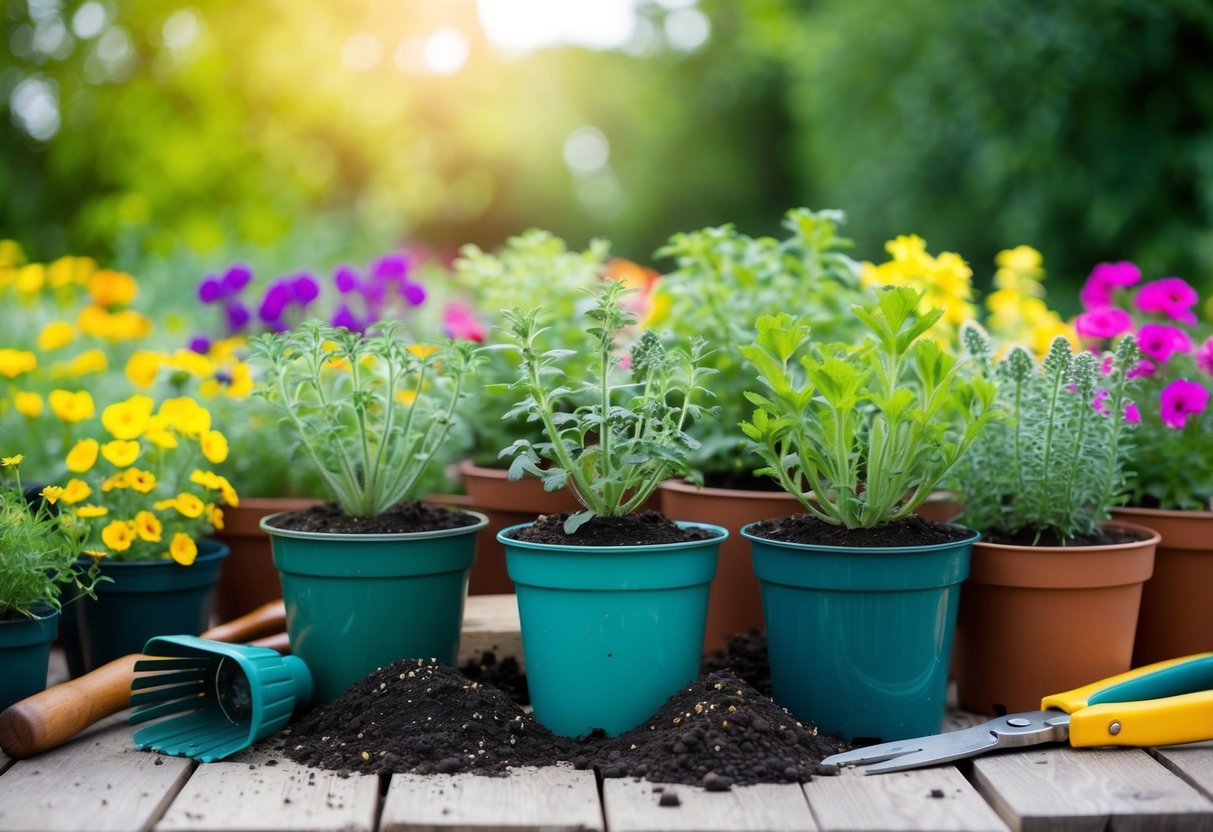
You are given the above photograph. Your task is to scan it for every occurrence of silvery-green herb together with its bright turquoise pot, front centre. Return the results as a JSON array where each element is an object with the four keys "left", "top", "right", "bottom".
[{"left": 497, "top": 280, "right": 728, "bottom": 736}]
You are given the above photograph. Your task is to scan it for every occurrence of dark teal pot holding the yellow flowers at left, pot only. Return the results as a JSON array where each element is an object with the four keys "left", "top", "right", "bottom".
[{"left": 63, "top": 540, "right": 228, "bottom": 677}]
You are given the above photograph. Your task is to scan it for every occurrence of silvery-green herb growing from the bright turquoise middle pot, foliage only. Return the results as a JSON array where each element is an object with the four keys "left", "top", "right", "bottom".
[{"left": 501, "top": 280, "right": 712, "bottom": 535}]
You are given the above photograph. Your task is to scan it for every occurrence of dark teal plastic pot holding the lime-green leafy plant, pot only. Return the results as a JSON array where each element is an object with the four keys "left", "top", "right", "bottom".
[{"left": 741, "top": 524, "right": 979, "bottom": 741}]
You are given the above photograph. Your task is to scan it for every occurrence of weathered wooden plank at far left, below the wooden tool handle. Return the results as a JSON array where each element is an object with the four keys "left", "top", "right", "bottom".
[{"left": 0, "top": 713, "right": 194, "bottom": 832}]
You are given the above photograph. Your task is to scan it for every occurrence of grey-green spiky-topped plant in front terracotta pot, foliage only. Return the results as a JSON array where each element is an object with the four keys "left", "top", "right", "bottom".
[{"left": 951, "top": 324, "right": 1140, "bottom": 543}]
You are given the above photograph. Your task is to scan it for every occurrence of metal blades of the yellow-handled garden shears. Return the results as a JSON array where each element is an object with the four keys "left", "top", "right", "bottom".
[{"left": 821, "top": 711, "right": 1070, "bottom": 774}]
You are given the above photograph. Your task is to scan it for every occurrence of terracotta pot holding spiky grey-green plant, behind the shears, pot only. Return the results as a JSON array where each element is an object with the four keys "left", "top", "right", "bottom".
[{"left": 956, "top": 523, "right": 1158, "bottom": 714}]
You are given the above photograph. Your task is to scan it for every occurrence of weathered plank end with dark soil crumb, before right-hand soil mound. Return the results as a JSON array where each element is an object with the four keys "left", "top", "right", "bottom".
[{"left": 603, "top": 779, "right": 818, "bottom": 832}]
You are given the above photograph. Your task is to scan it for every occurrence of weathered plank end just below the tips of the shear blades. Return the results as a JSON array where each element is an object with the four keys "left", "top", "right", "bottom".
[{"left": 804, "top": 765, "right": 1007, "bottom": 832}]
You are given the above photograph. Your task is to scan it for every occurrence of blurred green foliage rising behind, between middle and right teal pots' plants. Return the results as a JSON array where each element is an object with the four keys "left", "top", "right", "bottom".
[{"left": 656, "top": 209, "right": 866, "bottom": 485}]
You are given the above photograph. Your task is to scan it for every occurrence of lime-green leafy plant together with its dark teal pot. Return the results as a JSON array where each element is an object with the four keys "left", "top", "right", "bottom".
[{"left": 741, "top": 287, "right": 996, "bottom": 740}]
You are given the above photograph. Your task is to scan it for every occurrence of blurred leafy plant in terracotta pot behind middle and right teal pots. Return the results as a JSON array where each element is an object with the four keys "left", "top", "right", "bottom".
[{"left": 654, "top": 209, "right": 864, "bottom": 650}]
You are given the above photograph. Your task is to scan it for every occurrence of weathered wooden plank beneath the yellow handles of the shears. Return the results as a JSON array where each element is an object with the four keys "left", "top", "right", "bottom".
[{"left": 973, "top": 747, "right": 1213, "bottom": 832}]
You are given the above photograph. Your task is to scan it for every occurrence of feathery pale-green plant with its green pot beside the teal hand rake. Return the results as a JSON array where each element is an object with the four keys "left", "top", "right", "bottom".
[{"left": 252, "top": 321, "right": 488, "bottom": 701}]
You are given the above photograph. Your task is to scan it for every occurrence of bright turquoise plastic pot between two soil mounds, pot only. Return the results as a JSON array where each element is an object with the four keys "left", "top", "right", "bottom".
[{"left": 497, "top": 523, "right": 729, "bottom": 736}]
